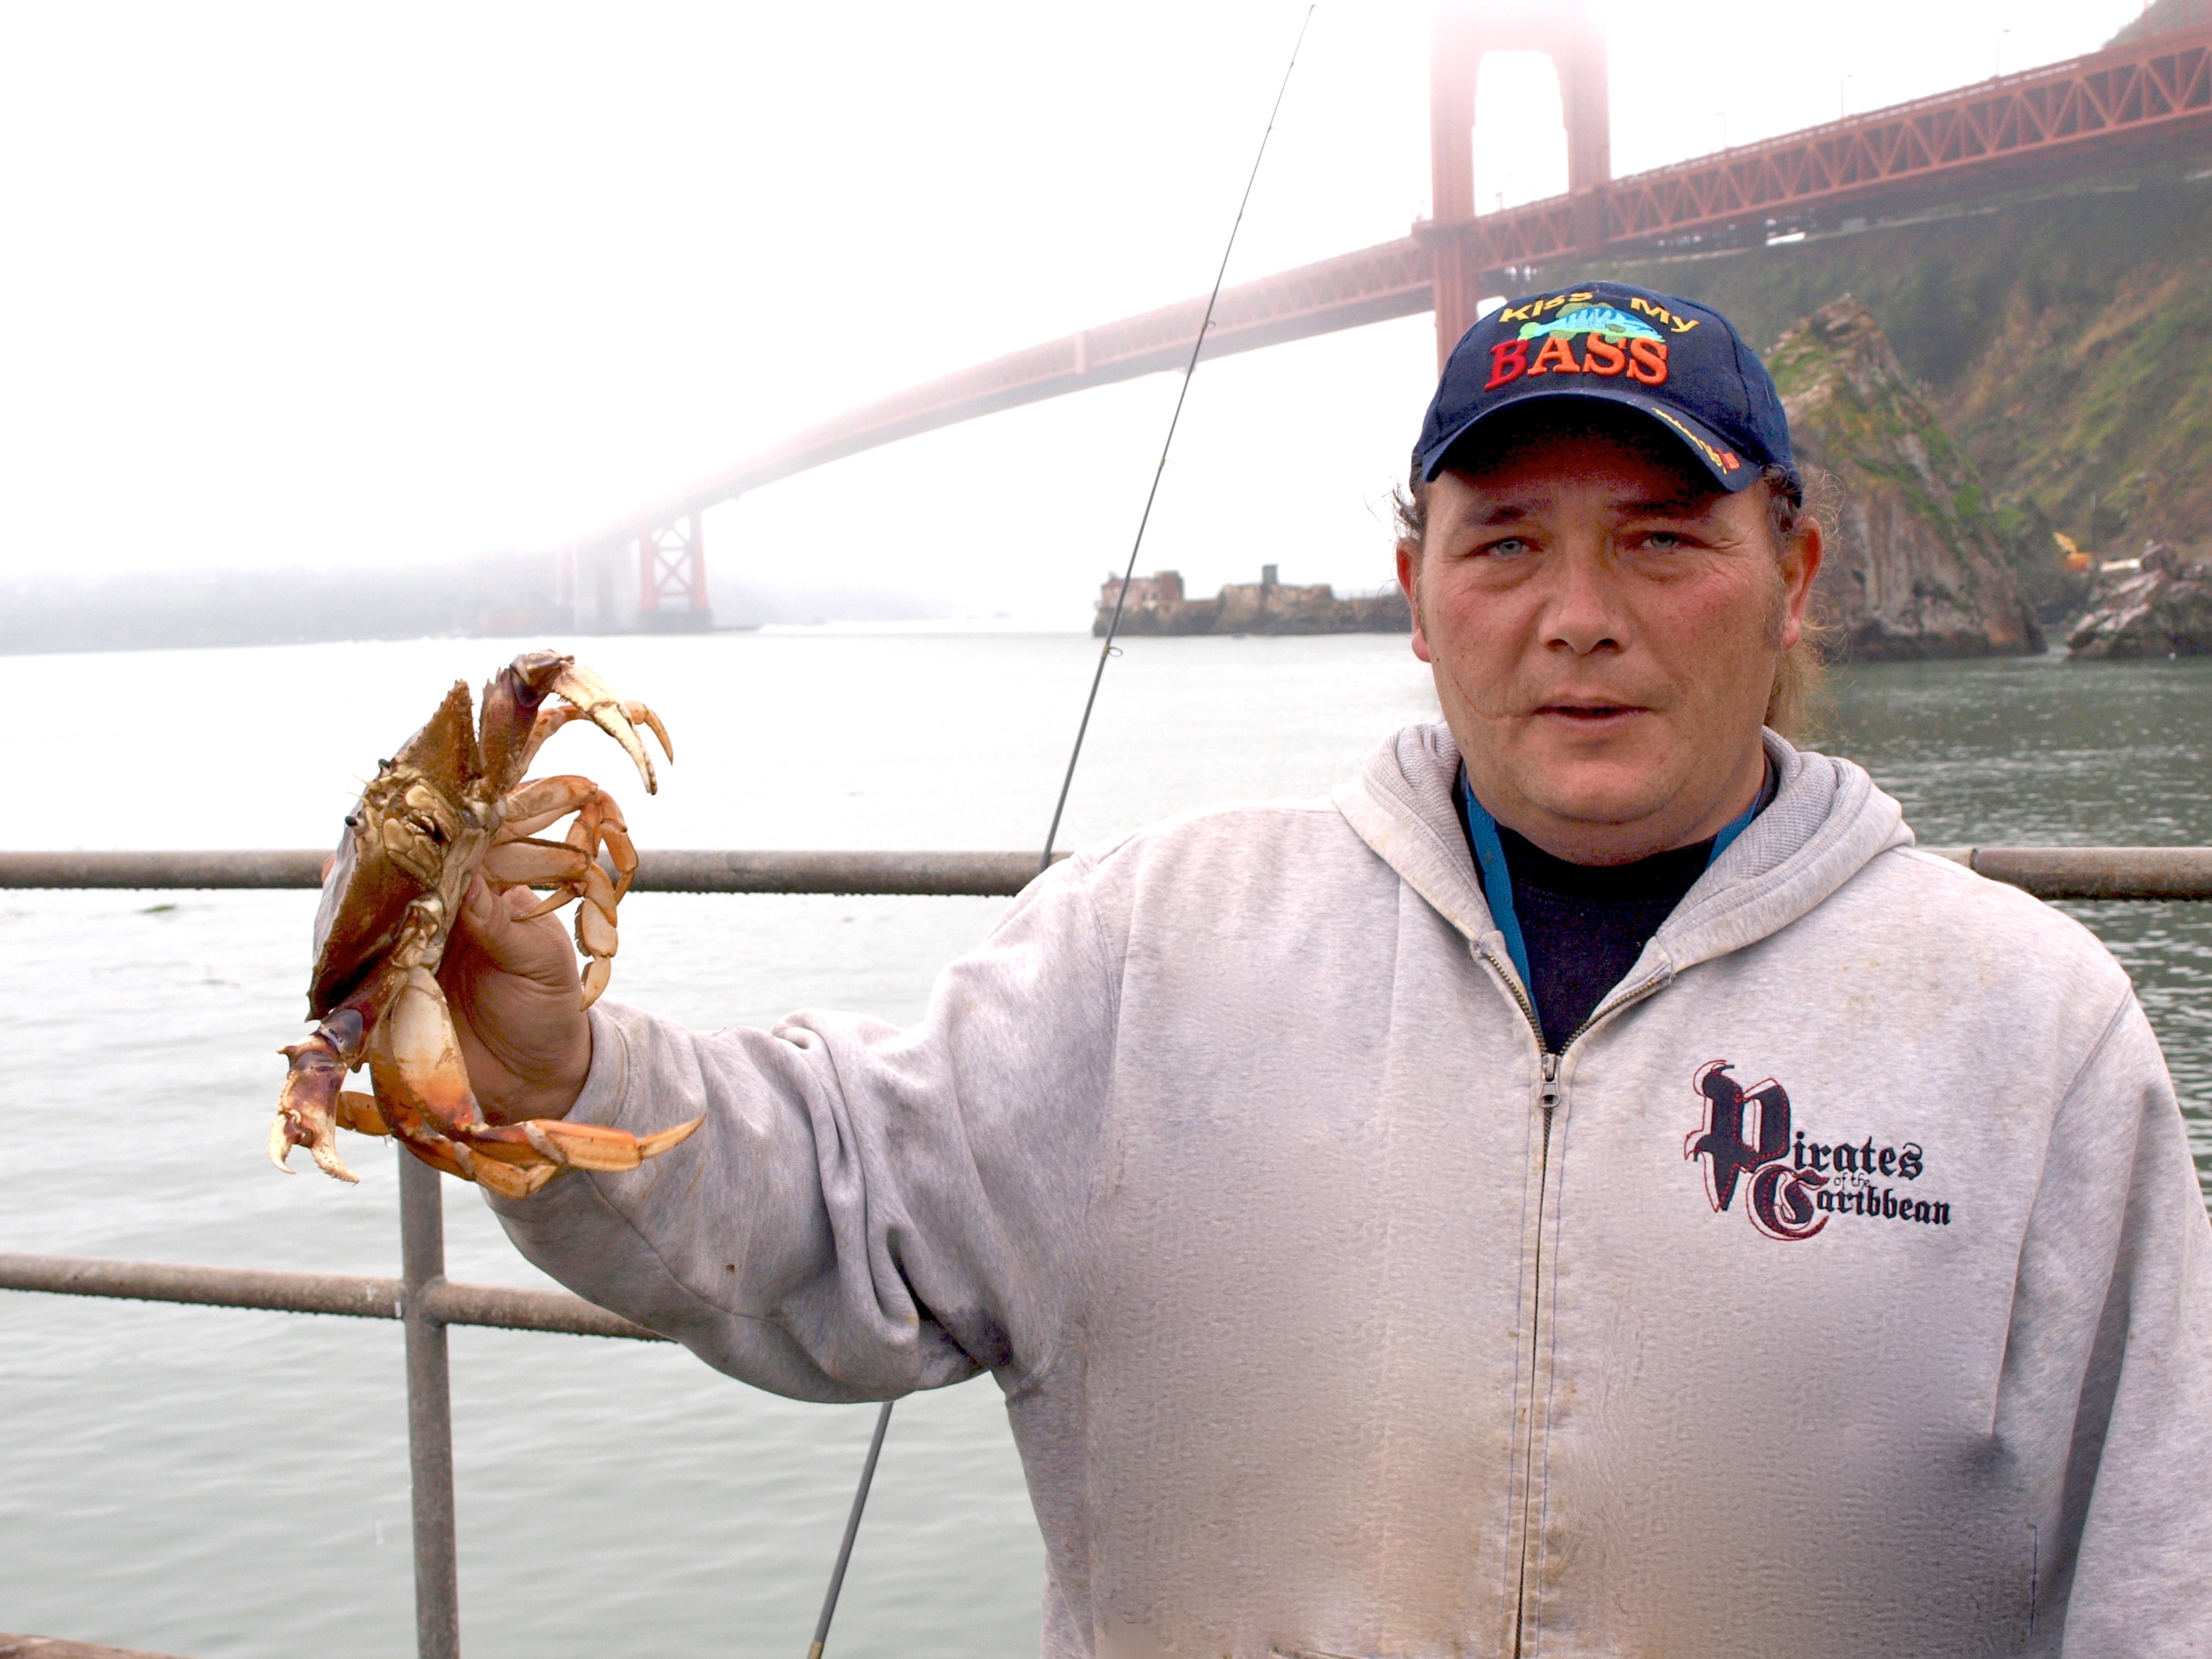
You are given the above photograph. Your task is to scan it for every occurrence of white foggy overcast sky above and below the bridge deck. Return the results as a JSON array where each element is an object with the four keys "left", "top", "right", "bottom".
[{"left": 0, "top": 0, "right": 2141, "bottom": 621}]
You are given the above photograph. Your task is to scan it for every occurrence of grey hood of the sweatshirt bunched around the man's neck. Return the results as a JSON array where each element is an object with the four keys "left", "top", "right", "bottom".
[{"left": 1334, "top": 723, "right": 1913, "bottom": 971}]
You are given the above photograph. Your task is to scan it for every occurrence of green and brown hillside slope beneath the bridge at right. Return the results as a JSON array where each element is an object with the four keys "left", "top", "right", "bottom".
[{"left": 1559, "top": 173, "right": 2212, "bottom": 602}]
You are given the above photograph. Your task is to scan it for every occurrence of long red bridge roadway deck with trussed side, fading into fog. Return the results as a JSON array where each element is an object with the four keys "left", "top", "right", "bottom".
[{"left": 577, "top": 16, "right": 2212, "bottom": 571}]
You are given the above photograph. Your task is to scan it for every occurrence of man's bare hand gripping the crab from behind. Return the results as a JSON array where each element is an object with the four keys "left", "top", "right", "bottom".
[{"left": 438, "top": 878, "right": 591, "bottom": 1124}]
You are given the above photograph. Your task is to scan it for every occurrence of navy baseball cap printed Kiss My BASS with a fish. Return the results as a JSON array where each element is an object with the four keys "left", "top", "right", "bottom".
[{"left": 1413, "top": 283, "right": 1796, "bottom": 491}]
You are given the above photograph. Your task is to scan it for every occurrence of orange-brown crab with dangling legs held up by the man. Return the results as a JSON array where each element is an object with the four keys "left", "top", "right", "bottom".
[{"left": 270, "top": 650, "right": 699, "bottom": 1197}]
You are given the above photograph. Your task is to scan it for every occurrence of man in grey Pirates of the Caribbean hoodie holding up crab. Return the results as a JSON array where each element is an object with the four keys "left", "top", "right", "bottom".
[{"left": 447, "top": 283, "right": 2212, "bottom": 1659}]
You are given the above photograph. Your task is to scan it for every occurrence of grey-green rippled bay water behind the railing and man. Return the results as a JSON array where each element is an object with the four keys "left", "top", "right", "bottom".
[{"left": 0, "top": 631, "right": 2212, "bottom": 1659}]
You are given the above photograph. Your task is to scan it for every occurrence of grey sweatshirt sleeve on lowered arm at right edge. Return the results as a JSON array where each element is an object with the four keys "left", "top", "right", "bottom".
[{"left": 2007, "top": 995, "right": 2212, "bottom": 1659}]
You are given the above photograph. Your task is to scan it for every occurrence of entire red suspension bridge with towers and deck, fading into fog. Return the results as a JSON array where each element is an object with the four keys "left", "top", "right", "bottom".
[{"left": 566, "top": 5, "right": 2212, "bottom": 631}]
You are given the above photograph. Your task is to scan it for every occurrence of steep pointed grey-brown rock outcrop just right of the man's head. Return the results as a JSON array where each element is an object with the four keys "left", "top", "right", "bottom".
[{"left": 1770, "top": 299, "right": 2044, "bottom": 661}]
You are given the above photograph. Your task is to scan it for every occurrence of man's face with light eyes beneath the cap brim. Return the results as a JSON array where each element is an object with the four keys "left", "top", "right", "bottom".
[{"left": 1398, "top": 411, "right": 1821, "bottom": 865}]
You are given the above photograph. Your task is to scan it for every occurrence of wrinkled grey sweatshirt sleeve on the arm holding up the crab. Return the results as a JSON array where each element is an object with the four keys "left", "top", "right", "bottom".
[{"left": 486, "top": 858, "right": 1117, "bottom": 1400}]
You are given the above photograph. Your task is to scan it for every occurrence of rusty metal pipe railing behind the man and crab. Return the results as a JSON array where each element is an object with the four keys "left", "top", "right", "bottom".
[{"left": 0, "top": 847, "right": 2212, "bottom": 1659}]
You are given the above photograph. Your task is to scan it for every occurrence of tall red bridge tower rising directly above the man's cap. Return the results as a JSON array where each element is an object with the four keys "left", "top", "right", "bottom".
[{"left": 1429, "top": 0, "right": 1613, "bottom": 365}]
